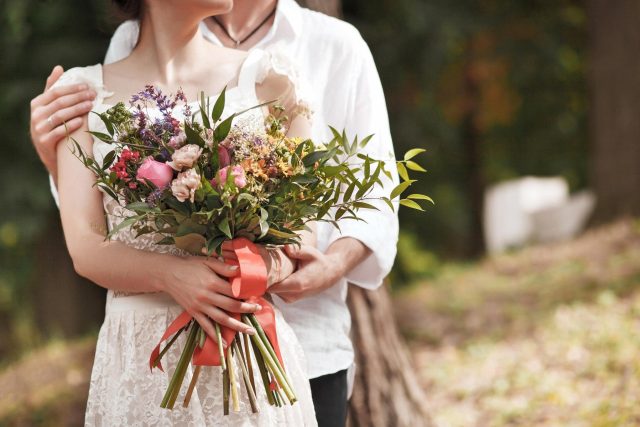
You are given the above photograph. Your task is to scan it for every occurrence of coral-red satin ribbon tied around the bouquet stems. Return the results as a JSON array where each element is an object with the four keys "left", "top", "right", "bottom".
[{"left": 149, "top": 237, "right": 284, "bottom": 372}]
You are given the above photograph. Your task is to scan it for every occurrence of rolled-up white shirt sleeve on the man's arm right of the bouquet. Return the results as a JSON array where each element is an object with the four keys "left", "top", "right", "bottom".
[{"left": 329, "top": 36, "right": 398, "bottom": 289}]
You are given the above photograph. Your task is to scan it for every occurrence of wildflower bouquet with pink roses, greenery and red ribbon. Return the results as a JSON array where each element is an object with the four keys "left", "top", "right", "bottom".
[{"left": 74, "top": 86, "right": 430, "bottom": 414}]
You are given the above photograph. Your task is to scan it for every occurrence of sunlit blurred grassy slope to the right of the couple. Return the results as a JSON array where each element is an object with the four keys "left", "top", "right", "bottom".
[{"left": 396, "top": 221, "right": 640, "bottom": 427}]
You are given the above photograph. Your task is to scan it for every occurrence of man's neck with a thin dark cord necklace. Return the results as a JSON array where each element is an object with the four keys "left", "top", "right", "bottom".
[{"left": 206, "top": 0, "right": 278, "bottom": 50}]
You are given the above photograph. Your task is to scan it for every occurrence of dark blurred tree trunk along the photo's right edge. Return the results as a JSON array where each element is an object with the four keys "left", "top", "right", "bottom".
[{"left": 587, "top": 0, "right": 640, "bottom": 222}]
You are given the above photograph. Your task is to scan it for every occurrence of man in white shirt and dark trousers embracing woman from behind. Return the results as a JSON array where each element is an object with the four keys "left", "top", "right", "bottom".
[{"left": 31, "top": 0, "right": 398, "bottom": 427}]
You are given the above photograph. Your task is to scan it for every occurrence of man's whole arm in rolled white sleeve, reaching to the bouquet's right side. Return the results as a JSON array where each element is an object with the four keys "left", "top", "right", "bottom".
[{"left": 270, "top": 31, "right": 398, "bottom": 302}]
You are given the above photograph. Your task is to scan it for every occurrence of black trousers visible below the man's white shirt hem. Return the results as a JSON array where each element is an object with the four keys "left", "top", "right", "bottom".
[{"left": 310, "top": 369, "right": 348, "bottom": 427}]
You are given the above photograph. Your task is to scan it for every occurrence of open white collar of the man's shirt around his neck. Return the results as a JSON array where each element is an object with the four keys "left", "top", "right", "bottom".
[{"left": 200, "top": 0, "right": 302, "bottom": 48}]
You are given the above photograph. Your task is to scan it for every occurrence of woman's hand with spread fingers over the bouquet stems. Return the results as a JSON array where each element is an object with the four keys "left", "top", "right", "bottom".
[{"left": 161, "top": 256, "right": 261, "bottom": 340}]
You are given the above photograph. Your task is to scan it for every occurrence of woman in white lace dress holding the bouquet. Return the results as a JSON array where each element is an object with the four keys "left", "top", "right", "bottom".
[{"left": 57, "top": 0, "right": 316, "bottom": 426}]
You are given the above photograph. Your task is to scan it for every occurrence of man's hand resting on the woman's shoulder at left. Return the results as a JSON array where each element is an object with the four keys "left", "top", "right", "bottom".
[{"left": 30, "top": 65, "right": 96, "bottom": 180}]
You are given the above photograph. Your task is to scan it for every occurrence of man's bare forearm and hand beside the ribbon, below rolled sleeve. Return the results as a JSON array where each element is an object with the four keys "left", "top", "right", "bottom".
[{"left": 269, "top": 237, "right": 371, "bottom": 302}]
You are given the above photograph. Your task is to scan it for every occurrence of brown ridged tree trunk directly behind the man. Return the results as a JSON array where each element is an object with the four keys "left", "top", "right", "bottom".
[{"left": 298, "top": 0, "right": 432, "bottom": 427}]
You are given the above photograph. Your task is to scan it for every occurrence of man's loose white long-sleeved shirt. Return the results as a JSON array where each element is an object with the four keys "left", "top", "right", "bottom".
[{"left": 65, "top": 0, "right": 398, "bottom": 378}]
